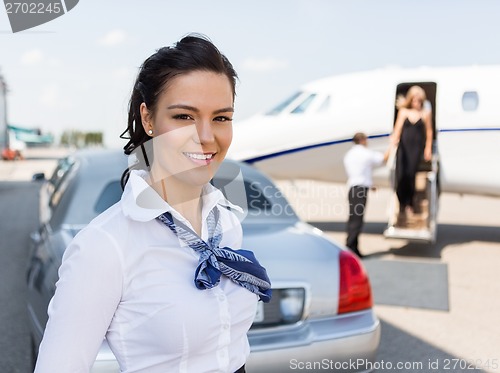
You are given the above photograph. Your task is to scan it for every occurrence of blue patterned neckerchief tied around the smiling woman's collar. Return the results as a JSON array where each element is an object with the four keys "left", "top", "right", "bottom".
[{"left": 157, "top": 207, "right": 271, "bottom": 302}]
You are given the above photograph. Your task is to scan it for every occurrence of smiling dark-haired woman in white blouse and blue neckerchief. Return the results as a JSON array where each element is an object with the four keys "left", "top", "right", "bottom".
[{"left": 35, "top": 35, "right": 271, "bottom": 373}]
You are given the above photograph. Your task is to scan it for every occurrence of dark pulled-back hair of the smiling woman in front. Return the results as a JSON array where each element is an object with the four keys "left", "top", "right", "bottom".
[{"left": 120, "top": 34, "right": 238, "bottom": 185}]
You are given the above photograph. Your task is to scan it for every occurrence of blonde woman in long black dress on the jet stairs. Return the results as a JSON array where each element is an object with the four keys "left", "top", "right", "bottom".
[{"left": 393, "top": 86, "right": 432, "bottom": 214}]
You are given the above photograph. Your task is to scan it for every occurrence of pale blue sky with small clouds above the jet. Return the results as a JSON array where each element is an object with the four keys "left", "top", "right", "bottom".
[{"left": 0, "top": 0, "right": 500, "bottom": 147}]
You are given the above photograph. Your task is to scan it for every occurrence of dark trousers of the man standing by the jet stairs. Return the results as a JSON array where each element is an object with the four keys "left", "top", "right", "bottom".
[{"left": 346, "top": 185, "right": 369, "bottom": 256}]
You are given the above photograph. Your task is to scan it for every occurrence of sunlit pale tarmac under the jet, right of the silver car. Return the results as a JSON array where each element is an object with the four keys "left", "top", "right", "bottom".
[{"left": 278, "top": 180, "right": 500, "bottom": 372}]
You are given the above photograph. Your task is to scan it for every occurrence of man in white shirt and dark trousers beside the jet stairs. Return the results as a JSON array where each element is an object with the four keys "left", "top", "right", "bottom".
[{"left": 344, "top": 132, "right": 389, "bottom": 257}]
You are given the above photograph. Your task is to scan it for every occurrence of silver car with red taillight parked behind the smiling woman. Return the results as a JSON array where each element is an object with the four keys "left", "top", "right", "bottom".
[{"left": 27, "top": 150, "right": 380, "bottom": 373}]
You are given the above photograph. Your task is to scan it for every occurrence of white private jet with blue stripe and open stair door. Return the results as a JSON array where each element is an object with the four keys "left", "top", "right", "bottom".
[{"left": 229, "top": 65, "right": 500, "bottom": 242}]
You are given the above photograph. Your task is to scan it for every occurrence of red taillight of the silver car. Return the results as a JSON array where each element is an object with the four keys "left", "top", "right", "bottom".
[{"left": 338, "top": 250, "right": 373, "bottom": 314}]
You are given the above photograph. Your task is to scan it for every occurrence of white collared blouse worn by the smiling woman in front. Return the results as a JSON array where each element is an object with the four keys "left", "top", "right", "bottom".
[{"left": 35, "top": 171, "right": 258, "bottom": 373}]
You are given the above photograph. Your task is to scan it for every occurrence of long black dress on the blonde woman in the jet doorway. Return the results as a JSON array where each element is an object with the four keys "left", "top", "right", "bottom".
[{"left": 396, "top": 118, "right": 425, "bottom": 211}]
